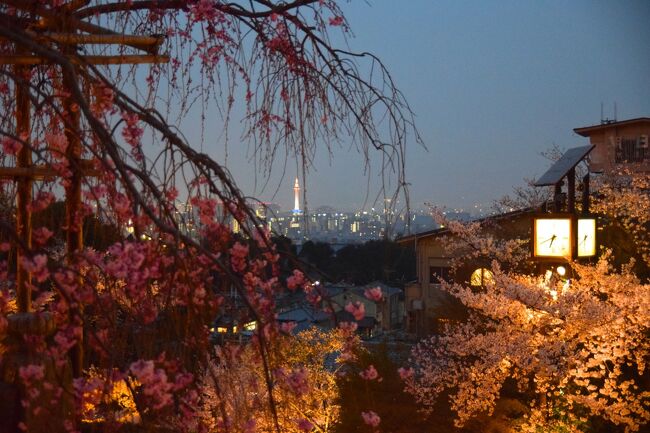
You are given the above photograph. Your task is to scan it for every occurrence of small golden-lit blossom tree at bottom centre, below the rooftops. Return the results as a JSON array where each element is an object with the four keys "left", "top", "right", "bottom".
[{"left": 201, "top": 329, "right": 346, "bottom": 433}]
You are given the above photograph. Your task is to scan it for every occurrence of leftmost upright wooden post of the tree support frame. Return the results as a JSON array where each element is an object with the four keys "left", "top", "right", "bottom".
[{"left": 15, "top": 66, "right": 32, "bottom": 313}]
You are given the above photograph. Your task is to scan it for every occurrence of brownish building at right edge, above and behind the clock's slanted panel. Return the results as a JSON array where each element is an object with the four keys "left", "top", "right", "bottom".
[{"left": 573, "top": 117, "right": 650, "bottom": 173}]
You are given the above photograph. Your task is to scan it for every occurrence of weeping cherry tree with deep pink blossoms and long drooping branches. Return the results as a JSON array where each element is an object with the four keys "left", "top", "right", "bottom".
[{"left": 0, "top": 0, "right": 419, "bottom": 431}]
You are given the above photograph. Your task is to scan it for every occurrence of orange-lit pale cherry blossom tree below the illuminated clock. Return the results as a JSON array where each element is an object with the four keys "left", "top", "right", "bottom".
[{"left": 401, "top": 203, "right": 650, "bottom": 432}]
